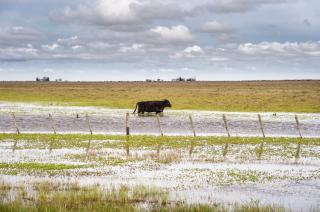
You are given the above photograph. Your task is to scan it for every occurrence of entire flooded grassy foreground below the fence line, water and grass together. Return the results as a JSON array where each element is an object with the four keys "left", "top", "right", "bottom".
[{"left": 0, "top": 134, "right": 320, "bottom": 211}]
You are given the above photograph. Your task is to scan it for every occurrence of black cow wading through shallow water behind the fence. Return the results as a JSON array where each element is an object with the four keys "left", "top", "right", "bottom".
[{"left": 133, "top": 99, "right": 171, "bottom": 114}]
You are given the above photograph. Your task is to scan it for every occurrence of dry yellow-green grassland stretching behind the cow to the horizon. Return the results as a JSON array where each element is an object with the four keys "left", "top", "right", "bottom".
[{"left": 0, "top": 80, "right": 320, "bottom": 112}]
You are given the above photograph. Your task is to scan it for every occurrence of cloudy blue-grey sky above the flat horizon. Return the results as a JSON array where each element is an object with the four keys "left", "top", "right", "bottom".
[{"left": 0, "top": 0, "right": 320, "bottom": 81}]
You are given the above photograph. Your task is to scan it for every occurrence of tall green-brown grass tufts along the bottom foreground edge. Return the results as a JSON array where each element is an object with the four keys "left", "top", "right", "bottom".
[{"left": 0, "top": 182, "right": 285, "bottom": 212}]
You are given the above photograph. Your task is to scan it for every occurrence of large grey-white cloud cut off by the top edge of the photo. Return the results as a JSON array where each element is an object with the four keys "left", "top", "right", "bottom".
[{"left": 51, "top": 0, "right": 191, "bottom": 27}]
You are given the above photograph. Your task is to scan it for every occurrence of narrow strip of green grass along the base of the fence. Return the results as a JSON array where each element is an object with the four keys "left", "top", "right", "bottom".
[{"left": 0, "top": 133, "right": 320, "bottom": 149}]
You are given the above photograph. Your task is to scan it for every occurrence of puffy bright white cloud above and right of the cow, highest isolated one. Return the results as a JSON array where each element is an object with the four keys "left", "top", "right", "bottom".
[{"left": 150, "top": 25, "right": 194, "bottom": 42}]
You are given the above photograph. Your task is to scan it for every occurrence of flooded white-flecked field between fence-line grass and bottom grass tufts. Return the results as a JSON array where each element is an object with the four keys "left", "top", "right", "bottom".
[{"left": 0, "top": 136, "right": 320, "bottom": 211}]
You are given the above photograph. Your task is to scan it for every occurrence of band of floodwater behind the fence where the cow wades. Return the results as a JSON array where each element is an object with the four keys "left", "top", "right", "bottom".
[{"left": 0, "top": 103, "right": 320, "bottom": 137}]
